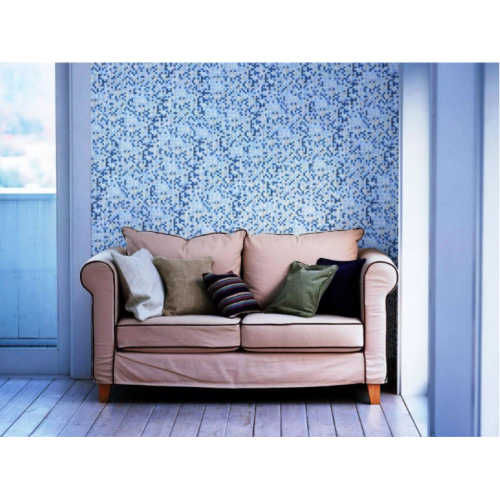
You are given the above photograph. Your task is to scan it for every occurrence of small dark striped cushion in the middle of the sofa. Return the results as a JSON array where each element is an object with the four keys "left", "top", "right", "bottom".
[{"left": 203, "top": 272, "right": 262, "bottom": 318}]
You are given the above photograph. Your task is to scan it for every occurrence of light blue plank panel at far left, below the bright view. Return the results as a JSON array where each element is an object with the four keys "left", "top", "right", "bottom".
[{"left": 0, "top": 193, "right": 57, "bottom": 346}]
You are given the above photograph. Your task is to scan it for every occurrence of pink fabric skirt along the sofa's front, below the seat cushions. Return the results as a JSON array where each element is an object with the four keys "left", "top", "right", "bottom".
[{"left": 112, "top": 351, "right": 365, "bottom": 389}]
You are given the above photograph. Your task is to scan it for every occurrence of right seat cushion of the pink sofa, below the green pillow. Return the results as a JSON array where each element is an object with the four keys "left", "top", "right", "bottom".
[{"left": 241, "top": 314, "right": 363, "bottom": 352}]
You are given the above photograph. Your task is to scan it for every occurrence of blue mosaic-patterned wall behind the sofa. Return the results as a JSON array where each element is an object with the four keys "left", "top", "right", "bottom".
[{"left": 91, "top": 63, "right": 399, "bottom": 356}]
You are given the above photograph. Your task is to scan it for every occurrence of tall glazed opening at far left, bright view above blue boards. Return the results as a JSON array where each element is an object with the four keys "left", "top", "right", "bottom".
[{"left": 0, "top": 64, "right": 58, "bottom": 348}]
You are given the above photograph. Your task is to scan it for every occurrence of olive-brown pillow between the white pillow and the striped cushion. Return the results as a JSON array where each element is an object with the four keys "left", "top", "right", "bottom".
[{"left": 153, "top": 257, "right": 220, "bottom": 316}]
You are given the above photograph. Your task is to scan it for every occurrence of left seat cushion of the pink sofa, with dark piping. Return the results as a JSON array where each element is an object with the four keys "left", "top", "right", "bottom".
[{"left": 116, "top": 315, "right": 241, "bottom": 354}]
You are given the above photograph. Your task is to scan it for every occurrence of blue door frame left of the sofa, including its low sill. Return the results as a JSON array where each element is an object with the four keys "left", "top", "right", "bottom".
[{"left": 0, "top": 63, "right": 92, "bottom": 378}]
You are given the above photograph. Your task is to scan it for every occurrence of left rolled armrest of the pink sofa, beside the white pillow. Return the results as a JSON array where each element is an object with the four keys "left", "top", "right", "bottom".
[{"left": 80, "top": 248, "right": 126, "bottom": 384}]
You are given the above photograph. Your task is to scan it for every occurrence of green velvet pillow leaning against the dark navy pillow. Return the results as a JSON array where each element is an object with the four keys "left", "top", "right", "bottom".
[{"left": 264, "top": 262, "right": 338, "bottom": 318}]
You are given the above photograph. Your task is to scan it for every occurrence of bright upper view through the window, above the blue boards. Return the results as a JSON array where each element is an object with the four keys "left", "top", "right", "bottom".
[{"left": 0, "top": 63, "right": 56, "bottom": 191}]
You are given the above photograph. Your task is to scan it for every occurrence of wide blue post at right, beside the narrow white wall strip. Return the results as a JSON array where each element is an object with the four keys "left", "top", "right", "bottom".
[{"left": 429, "top": 63, "right": 498, "bottom": 436}]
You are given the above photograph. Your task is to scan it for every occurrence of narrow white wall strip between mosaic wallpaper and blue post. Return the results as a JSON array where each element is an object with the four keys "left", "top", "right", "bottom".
[{"left": 398, "top": 64, "right": 430, "bottom": 396}]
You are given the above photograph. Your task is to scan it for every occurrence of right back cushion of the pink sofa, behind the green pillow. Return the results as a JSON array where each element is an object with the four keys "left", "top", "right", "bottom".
[{"left": 243, "top": 229, "right": 364, "bottom": 309}]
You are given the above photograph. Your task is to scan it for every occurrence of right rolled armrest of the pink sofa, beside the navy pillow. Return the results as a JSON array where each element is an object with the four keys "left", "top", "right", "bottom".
[{"left": 358, "top": 248, "right": 398, "bottom": 384}]
